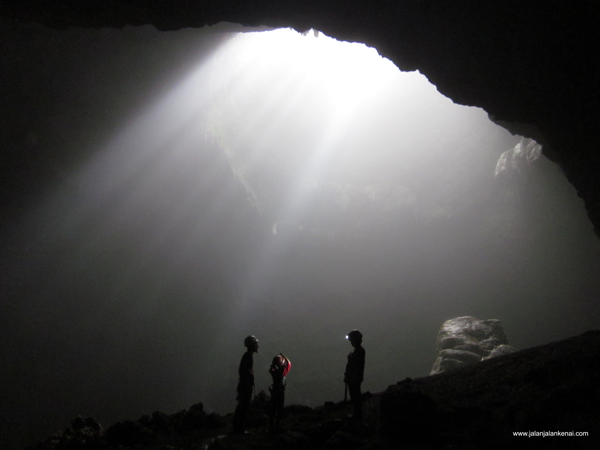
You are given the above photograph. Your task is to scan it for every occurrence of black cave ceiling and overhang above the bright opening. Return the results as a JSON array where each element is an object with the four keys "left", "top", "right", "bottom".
[{"left": 0, "top": 0, "right": 600, "bottom": 234}]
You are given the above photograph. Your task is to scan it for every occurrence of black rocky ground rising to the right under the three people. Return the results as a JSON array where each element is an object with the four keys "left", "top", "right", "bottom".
[{"left": 27, "top": 331, "right": 600, "bottom": 450}]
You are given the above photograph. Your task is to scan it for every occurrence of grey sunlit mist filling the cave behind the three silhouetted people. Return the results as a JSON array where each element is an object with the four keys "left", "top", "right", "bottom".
[{"left": 0, "top": 23, "right": 600, "bottom": 448}]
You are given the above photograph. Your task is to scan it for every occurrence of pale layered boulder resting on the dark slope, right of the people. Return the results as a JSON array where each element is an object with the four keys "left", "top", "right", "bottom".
[{"left": 430, "top": 316, "right": 515, "bottom": 375}]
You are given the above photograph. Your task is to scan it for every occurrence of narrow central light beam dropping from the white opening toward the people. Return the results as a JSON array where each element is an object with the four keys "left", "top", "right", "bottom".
[{"left": 214, "top": 29, "right": 435, "bottom": 317}]
